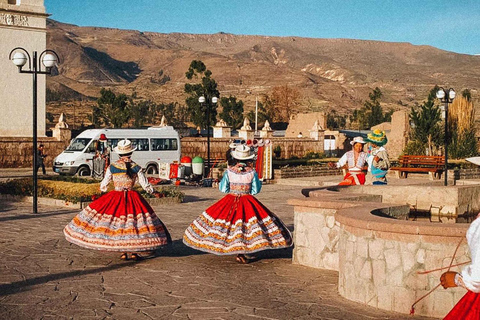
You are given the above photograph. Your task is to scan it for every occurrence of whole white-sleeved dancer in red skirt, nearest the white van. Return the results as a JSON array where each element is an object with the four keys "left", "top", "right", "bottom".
[{"left": 63, "top": 140, "right": 171, "bottom": 260}]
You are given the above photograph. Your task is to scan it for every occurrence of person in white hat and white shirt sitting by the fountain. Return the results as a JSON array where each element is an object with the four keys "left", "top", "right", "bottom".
[{"left": 328, "top": 137, "right": 367, "bottom": 186}]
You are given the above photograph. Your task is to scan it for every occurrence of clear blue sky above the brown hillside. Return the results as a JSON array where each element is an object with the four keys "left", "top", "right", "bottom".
[{"left": 45, "top": 0, "right": 480, "bottom": 54}]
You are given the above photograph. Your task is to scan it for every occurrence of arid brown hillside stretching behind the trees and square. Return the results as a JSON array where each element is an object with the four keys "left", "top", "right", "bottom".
[{"left": 47, "top": 20, "right": 480, "bottom": 125}]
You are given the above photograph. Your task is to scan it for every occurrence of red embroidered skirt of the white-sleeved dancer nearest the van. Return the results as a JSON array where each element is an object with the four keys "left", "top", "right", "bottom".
[{"left": 63, "top": 191, "right": 171, "bottom": 252}]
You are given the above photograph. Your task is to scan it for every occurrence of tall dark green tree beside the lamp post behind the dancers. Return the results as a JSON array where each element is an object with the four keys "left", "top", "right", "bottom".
[{"left": 184, "top": 60, "right": 220, "bottom": 128}]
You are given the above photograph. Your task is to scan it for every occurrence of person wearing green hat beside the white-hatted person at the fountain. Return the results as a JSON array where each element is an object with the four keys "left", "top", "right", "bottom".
[{"left": 366, "top": 129, "right": 390, "bottom": 185}]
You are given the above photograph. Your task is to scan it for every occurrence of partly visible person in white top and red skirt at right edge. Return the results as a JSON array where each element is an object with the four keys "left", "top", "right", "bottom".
[{"left": 440, "top": 214, "right": 480, "bottom": 320}]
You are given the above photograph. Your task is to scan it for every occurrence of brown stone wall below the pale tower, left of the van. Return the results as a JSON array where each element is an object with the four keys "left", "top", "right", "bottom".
[{"left": 0, "top": 137, "right": 70, "bottom": 168}]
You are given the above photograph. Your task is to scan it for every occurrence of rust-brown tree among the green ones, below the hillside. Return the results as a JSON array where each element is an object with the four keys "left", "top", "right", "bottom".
[{"left": 271, "top": 84, "right": 300, "bottom": 122}]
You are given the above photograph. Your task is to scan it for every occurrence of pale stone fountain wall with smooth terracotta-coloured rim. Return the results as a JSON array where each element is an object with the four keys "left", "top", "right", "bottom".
[{"left": 288, "top": 186, "right": 474, "bottom": 317}]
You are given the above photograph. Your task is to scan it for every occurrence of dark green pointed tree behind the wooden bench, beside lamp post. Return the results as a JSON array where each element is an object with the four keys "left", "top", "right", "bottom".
[{"left": 405, "top": 86, "right": 443, "bottom": 154}]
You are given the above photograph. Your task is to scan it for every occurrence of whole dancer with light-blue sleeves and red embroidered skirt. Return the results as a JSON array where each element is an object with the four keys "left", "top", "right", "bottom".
[{"left": 183, "top": 145, "right": 292, "bottom": 263}]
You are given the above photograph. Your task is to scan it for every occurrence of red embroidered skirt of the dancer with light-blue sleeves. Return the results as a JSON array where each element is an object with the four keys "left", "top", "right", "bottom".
[{"left": 183, "top": 194, "right": 292, "bottom": 255}]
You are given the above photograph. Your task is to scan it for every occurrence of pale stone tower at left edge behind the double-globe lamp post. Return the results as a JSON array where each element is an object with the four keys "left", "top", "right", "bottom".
[{"left": 0, "top": 0, "right": 48, "bottom": 137}]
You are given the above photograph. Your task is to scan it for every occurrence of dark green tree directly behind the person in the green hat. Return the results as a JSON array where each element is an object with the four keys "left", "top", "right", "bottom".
[{"left": 350, "top": 87, "right": 393, "bottom": 129}]
